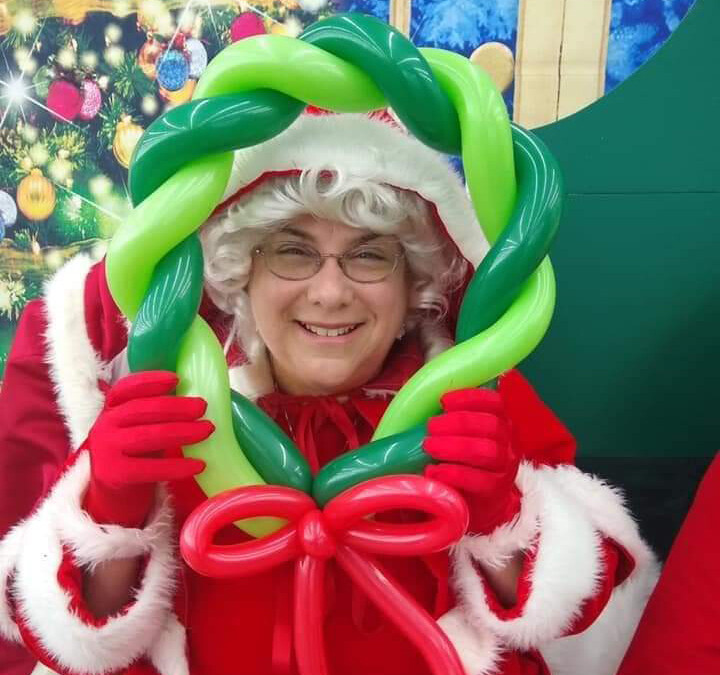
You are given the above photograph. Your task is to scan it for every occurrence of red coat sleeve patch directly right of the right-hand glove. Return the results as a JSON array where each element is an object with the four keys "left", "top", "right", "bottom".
[{"left": 498, "top": 370, "right": 576, "bottom": 466}]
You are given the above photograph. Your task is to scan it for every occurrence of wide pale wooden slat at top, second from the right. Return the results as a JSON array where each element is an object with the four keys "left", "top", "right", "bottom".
[{"left": 514, "top": 0, "right": 566, "bottom": 128}]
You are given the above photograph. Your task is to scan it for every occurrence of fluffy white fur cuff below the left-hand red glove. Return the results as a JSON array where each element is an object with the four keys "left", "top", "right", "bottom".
[{"left": 6, "top": 452, "right": 187, "bottom": 675}]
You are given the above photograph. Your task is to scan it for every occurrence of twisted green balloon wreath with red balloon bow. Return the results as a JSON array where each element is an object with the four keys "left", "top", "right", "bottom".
[{"left": 107, "top": 14, "right": 563, "bottom": 675}]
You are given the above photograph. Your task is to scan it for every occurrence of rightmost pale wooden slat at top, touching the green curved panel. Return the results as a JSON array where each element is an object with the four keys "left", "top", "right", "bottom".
[{"left": 557, "top": 0, "right": 612, "bottom": 119}]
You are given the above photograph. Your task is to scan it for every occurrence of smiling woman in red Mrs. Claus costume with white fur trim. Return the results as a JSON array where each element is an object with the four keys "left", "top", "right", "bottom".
[{"left": 0, "top": 115, "right": 654, "bottom": 675}]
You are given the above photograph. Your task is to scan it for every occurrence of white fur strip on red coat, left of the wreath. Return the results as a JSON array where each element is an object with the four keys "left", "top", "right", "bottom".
[{"left": 45, "top": 255, "right": 110, "bottom": 448}]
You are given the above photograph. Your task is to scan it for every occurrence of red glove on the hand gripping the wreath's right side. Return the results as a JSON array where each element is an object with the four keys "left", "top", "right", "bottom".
[{"left": 423, "top": 389, "right": 520, "bottom": 534}]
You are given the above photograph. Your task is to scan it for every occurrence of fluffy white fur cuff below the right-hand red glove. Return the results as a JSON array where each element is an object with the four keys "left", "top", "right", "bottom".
[{"left": 454, "top": 463, "right": 612, "bottom": 650}]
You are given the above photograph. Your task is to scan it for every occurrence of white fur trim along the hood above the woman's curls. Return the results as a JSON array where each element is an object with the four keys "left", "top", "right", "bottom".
[{"left": 222, "top": 114, "right": 488, "bottom": 267}]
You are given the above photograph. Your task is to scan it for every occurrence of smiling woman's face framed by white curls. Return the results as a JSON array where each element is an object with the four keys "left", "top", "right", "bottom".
[{"left": 247, "top": 216, "right": 409, "bottom": 395}]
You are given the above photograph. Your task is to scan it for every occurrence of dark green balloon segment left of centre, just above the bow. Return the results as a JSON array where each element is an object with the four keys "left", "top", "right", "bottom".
[{"left": 230, "top": 391, "right": 312, "bottom": 493}]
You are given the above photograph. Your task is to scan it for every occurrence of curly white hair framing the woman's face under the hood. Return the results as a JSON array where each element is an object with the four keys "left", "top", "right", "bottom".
[{"left": 200, "top": 169, "right": 468, "bottom": 363}]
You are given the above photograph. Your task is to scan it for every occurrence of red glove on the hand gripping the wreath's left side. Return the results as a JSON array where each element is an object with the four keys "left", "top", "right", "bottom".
[{"left": 83, "top": 371, "right": 215, "bottom": 527}]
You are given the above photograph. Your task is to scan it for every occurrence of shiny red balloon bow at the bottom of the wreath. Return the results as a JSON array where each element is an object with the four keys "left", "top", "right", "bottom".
[{"left": 180, "top": 475, "right": 468, "bottom": 675}]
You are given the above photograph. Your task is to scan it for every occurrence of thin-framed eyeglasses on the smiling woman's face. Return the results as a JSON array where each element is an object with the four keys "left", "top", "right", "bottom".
[{"left": 255, "top": 241, "right": 403, "bottom": 284}]
